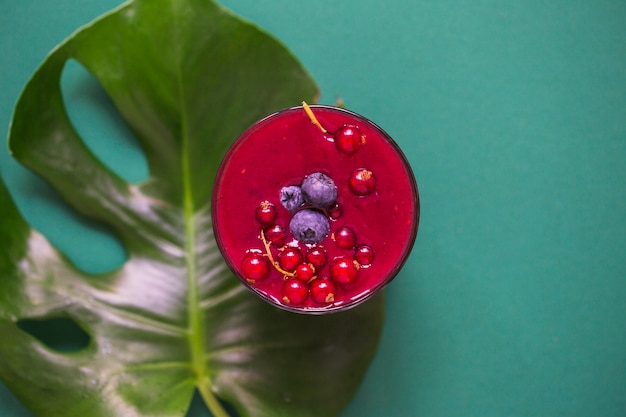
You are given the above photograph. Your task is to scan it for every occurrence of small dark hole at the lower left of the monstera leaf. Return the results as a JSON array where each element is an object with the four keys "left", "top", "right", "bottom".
[{"left": 17, "top": 317, "right": 91, "bottom": 353}]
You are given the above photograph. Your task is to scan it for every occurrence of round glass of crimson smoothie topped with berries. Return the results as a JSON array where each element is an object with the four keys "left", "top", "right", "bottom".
[{"left": 212, "top": 105, "right": 419, "bottom": 314}]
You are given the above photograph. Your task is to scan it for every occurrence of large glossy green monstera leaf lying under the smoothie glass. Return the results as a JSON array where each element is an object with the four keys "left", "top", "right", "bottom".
[{"left": 0, "top": 0, "right": 382, "bottom": 417}]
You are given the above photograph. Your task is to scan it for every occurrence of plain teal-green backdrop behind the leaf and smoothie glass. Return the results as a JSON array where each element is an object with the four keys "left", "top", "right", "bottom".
[{"left": 0, "top": 0, "right": 626, "bottom": 417}]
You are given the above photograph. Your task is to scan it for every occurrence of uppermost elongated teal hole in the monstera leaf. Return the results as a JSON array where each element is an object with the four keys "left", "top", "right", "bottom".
[{"left": 61, "top": 59, "right": 149, "bottom": 183}]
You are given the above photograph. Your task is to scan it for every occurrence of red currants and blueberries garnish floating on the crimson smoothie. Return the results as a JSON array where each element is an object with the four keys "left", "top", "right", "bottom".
[{"left": 240, "top": 107, "right": 376, "bottom": 306}]
